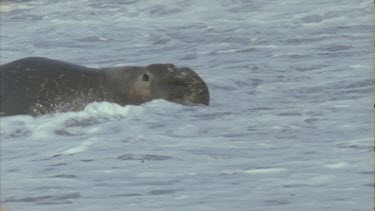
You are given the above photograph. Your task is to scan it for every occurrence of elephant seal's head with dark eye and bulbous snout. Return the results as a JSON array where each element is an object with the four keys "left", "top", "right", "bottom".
[{"left": 107, "top": 64, "right": 210, "bottom": 105}]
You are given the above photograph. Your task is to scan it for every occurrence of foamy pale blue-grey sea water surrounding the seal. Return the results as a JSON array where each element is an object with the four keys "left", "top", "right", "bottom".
[{"left": 0, "top": 0, "right": 374, "bottom": 211}]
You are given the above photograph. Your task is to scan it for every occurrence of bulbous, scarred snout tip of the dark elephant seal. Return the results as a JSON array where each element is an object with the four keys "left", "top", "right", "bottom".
[{"left": 175, "top": 67, "right": 210, "bottom": 105}]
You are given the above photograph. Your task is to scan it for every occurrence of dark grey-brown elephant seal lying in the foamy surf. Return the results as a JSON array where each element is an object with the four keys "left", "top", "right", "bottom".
[{"left": 0, "top": 57, "right": 209, "bottom": 116}]
